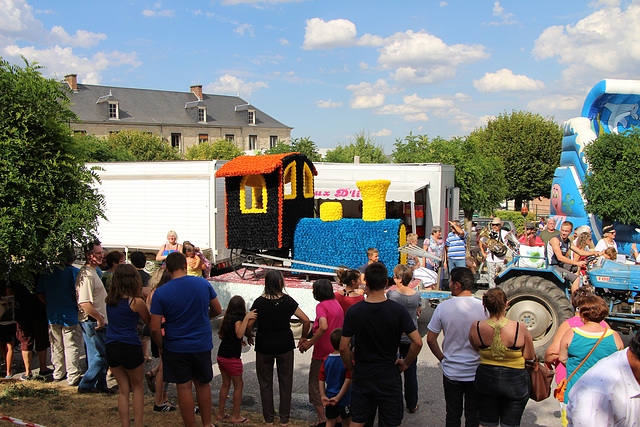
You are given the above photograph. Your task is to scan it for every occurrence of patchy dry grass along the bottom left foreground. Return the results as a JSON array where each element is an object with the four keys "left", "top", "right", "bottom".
[{"left": 0, "top": 380, "right": 308, "bottom": 427}]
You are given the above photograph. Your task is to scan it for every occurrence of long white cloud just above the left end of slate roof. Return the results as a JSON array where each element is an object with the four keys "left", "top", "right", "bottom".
[{"left": 4, "top": 45, "right": 141, "bottom": 84}]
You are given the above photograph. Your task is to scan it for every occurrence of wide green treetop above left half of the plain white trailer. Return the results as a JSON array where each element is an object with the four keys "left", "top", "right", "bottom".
[{"left": 106, "top": 130, "right": 182, "bottom": 162}]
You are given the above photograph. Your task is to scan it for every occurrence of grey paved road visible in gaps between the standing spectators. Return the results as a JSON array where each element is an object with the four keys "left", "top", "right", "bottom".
[{"left": 202, "top": 309, "right": 560, "bottom": 427}]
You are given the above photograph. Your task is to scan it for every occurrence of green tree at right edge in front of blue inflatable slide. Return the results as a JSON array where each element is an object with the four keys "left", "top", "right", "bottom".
[{"left": 582, "top": 129, "right": 640, "bottom": 224}]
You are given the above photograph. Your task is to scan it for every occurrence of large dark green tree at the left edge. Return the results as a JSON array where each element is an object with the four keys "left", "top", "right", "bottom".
[{"left": 0, "top": 58, "right": 103, "bottom": 285}]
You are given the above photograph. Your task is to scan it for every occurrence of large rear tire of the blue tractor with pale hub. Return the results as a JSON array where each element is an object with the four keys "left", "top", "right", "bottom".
[{"left": 500, "top": 276, "right": 574, "bottom": 360}]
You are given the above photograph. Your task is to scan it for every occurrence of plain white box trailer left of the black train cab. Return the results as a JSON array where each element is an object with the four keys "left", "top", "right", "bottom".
[{"left": 86, "top": 160, "right": 230, "bottom": 265}]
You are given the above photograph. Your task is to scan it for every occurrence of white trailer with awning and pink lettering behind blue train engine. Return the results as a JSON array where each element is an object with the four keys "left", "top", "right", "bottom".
[{"left": 314, "top": 162, "right": 459, "bottom": 237}]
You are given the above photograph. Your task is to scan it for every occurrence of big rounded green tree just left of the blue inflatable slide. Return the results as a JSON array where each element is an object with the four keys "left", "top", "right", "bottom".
[{"left": 470, "top": 111, "right": 562, "bottom": 210}]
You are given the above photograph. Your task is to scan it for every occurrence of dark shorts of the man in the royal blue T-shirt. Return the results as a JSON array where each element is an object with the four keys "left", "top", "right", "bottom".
[{"left": 162, "top": 349, "right": 213, "bottom": 384}]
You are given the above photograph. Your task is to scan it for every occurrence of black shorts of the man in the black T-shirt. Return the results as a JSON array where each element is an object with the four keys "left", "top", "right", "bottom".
[{"left": 351, "top": 368, "right": 404, "bottom": 426}]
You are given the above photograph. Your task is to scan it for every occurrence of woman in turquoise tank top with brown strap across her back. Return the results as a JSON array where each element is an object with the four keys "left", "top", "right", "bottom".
[{"left": 558, "top": 295, "right": 624, "bottom": 426}]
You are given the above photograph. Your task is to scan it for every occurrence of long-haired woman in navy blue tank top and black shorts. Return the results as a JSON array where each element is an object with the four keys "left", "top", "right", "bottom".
[{"left": 105, "top": 264, "right": 151, "bottom": 427}]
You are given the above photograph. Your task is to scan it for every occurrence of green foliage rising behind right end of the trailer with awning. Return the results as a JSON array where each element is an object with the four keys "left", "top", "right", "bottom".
[{"left": 392, "top": 134, "right": 506, "bottom": 220}]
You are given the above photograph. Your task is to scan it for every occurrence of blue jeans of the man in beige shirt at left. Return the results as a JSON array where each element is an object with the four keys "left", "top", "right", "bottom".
[{"left": 78, "top": 320, "right": 109, "bottom": 390}]
